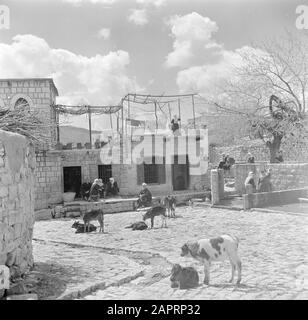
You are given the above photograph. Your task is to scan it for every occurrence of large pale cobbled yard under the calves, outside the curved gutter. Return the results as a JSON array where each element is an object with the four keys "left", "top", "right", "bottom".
[{"left": 34, "top": 206, "right": 308, "bottom": 299}]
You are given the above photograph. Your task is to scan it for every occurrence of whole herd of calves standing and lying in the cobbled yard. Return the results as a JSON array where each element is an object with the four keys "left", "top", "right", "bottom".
[{"left": 67, "top": 196, "right": 242, "bottom": 289}]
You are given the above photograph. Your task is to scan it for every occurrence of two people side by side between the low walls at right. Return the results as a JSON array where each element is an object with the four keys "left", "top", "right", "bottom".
[{"left": 245, "top": 169, "right": 273, "bottom": 194}]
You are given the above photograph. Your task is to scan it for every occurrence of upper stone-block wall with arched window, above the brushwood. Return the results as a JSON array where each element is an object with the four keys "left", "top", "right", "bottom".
[{"left": 0, "top": 79, "right": 58, "bottom": 150}]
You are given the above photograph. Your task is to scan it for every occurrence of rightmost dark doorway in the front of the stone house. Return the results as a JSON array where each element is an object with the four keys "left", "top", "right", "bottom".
[{"left": 172, "top": 155, "right": 189, "bottom": 190}]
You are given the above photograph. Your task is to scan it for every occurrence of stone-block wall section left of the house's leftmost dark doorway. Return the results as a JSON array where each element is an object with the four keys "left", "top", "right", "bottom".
[{"left": 35, "top": 151, "right": 63, "bottom": 209}]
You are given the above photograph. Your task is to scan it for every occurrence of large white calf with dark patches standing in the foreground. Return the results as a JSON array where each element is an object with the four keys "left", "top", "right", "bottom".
[{"left": 181, "top": 235, "right": 242, "bottom": 285}]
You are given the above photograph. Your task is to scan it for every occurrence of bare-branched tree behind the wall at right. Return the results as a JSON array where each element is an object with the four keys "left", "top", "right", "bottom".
[{"left": 208, "top": 32, "right": 308, "bottom": 162}]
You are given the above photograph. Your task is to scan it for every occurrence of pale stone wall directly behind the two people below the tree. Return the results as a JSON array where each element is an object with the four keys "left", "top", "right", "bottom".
[{"left": 234, "top": 163, "right": 308, "bottom": 194}]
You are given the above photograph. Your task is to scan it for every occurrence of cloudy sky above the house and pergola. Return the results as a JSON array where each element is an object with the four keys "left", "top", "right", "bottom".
[{"left": 0, "top": 0, "right": 308, "bottom": 129}]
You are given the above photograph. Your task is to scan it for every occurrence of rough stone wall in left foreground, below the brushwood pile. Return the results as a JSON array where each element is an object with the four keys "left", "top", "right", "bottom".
[{"left": 0, "top": 130, "right": 35, "bottom": 278}]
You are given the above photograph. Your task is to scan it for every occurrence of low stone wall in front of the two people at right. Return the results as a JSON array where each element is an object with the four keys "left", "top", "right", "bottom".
[{"left": 243, "top": 188, "right": 308, "bottom": 210}]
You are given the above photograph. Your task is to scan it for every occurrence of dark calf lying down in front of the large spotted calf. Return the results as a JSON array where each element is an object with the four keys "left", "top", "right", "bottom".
[{"left": 170, "top": 264, "right": 199, "bottom": 289}]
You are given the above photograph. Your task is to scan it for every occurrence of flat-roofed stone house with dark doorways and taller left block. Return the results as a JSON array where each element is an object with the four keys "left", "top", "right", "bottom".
[{"left": 0, "top": 78, "right": 210, "bottom": 209}]
